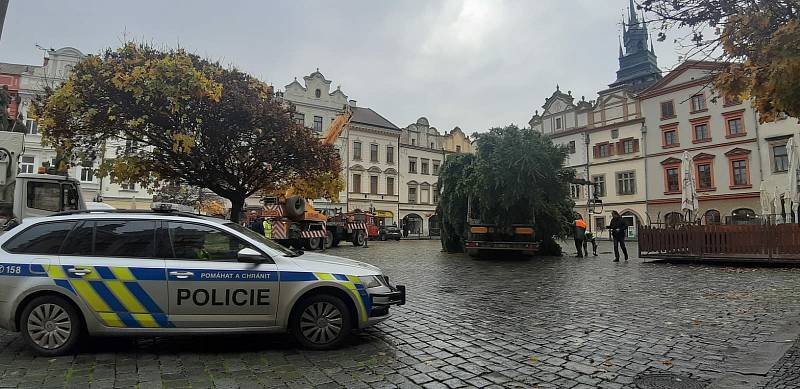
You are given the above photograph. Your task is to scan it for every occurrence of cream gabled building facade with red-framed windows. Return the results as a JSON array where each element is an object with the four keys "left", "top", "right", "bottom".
[{"left": 639, "top": 61, "right": 764, "bottom": 223}]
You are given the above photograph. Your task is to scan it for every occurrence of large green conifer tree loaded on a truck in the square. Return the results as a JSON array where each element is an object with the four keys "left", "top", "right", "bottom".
[{"left": 437, "top": 125, "right": 575, "bottom": 255}]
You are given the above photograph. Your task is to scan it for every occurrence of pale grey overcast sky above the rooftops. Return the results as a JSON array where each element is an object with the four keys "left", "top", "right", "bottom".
[{"left": 0, "top": 0, "right": 678, "bottom": 133}]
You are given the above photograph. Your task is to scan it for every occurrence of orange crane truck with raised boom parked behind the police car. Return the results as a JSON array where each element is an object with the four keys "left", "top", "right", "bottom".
[{"left": 248, "top": 107, "right": 372, "bottom": 250}]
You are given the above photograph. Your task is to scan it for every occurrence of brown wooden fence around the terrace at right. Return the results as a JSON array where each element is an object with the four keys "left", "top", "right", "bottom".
[{"left": 639, "top": 224, "right": 800, "bottom": 260}]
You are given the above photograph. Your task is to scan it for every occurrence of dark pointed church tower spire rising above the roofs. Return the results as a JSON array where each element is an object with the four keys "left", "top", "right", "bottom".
[{"left": 609, "top": 0, "right": 661, "bottom": 91}]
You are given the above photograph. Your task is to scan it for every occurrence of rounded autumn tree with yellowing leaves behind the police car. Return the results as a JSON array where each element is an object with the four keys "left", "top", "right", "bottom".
[{"left": 34, "top": 43, "right": 340, "bottom": 221}]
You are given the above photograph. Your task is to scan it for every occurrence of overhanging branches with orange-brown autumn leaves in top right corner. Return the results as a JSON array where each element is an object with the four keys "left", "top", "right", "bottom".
[{"left": 641, "top": 0, "right": 800, "bottom": 122}]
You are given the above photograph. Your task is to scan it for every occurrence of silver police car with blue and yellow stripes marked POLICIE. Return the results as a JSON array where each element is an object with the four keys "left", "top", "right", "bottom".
[{"left": 0, "top": 206, "right": 405, "bottom": 355}]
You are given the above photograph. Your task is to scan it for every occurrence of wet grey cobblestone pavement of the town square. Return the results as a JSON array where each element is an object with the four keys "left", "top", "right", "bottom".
[{"left": 0, "top": 241, "right": 800, "bottom": 389}]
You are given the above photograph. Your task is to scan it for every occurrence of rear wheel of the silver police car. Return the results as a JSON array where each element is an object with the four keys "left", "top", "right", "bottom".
[{"left": 20, "top": 296, "right": 83, "bottom": 356}]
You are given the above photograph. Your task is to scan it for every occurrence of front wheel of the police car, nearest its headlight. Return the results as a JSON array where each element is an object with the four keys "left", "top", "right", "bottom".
[{"left": 291, "top": 294, "right": 352, "bottom": 350}]
